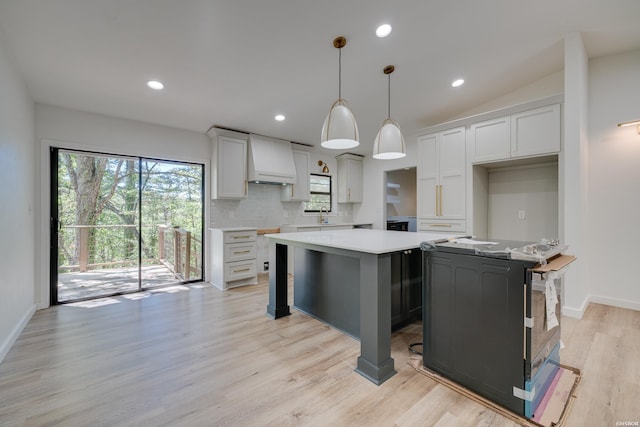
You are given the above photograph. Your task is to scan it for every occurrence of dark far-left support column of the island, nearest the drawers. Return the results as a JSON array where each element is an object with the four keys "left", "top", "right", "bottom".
[{"left": 267, "top": 243, "right": 291, "bottom": 319}]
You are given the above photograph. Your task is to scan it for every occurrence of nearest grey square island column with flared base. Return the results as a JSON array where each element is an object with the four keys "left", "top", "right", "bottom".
[{"left": 356, "top": 253, "right": 396, "bottom": 385}]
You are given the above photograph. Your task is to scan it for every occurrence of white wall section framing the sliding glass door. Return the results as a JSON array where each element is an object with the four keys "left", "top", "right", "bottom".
[{"left": 31, "top": 104, "right": 211, "bottom": 307}]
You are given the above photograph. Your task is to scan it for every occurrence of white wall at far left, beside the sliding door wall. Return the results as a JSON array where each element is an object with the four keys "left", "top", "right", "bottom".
[{"left": 0, "top": 34, "right": 35, "bottom": 362}]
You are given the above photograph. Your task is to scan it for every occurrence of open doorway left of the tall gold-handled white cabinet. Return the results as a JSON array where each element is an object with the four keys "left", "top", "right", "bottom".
[{"left": 384, "top": 167, "right": 417, "bottom": 231}]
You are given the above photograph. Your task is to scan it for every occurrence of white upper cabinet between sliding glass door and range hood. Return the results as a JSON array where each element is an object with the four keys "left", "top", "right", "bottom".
[{"left": 208, "top": 131, "right": 247, "bottom": 199}]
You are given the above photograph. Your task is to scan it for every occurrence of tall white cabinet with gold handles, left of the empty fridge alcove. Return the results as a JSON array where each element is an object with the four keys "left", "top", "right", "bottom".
[{"left": 417, "top": 127, "right": 466, "bottom": 231}]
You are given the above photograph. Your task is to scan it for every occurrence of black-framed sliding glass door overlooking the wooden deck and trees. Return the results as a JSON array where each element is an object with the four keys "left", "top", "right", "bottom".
[{"left": 50, "top": 148, "right": 204, "bottom": 304}]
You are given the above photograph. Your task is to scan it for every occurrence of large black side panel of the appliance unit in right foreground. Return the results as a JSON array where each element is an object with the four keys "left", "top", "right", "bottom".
[{"left": 423, "top": 247, "right": 535, "bottom": 414}]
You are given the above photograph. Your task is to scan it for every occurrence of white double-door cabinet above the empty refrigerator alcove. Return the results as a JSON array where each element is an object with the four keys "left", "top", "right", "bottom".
[{"left": 469, "top": 104, "right": 561, "bottom": 163}]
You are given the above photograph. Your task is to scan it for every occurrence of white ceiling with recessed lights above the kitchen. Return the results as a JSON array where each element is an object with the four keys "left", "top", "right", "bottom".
[{"left": 0, "top": 0, "right": 640, "bottom": 154}]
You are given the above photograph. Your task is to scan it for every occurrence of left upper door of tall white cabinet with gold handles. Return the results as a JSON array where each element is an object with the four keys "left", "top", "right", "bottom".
[{"left": 417, "top": 134, "right": 439, "bottom": 218}]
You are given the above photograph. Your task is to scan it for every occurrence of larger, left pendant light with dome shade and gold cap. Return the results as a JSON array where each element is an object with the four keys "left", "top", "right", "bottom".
[{"left": 320, "top": 36, "right": 360, "bottom": 150}]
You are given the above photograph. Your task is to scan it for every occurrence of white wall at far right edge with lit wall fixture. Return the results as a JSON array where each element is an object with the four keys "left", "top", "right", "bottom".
[{"left": 587, "top": 50, "right": 640, "bottom": 310}]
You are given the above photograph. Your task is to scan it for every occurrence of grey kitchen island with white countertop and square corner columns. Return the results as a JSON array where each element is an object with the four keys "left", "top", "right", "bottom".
[{"left": 266, "top": 229, "right": 457, "bottom": 385}]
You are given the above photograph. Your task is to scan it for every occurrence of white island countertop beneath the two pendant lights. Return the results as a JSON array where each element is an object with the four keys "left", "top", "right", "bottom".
[{"left": 265, "top": 228, "right": 460, "bottom": 254}]
